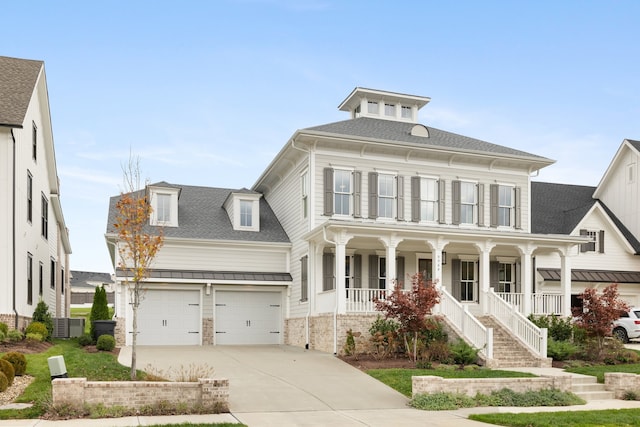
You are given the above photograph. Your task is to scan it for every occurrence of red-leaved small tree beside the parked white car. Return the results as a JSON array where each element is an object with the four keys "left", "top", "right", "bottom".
[{"left": 573, "top": 283, "right": 629, "bottom": 350}]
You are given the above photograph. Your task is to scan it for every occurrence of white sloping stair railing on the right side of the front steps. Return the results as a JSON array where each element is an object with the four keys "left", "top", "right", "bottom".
[{"left": 487, "top": 289, "right": 547, "bottom": 357}]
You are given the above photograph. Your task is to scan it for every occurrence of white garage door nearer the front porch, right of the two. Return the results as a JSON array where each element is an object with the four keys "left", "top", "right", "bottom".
[{"left": 214, "top": 291, "right": 282, "bottom": 345}]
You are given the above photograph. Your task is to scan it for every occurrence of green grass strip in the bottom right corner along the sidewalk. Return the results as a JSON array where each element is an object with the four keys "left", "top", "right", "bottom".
[{"left": 469, "top": 409, "right": 640, "bottom": 427}]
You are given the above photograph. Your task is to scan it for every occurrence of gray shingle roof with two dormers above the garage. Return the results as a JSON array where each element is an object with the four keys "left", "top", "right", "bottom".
[{"left": 107, "top": 184, "right": 289, "bottom": 243}]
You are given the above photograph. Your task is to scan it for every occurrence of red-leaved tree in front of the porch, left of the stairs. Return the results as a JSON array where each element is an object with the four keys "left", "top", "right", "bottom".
[{"left": 375, "top": 273, "right": 440, "bottom": 361}]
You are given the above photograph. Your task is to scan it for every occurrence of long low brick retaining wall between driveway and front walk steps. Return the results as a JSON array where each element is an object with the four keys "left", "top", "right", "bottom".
[{"left": 411, "top": 375, "right": 571, "bottom": 397}]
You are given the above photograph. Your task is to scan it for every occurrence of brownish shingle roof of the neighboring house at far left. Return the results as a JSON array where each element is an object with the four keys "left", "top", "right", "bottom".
[{"left": 0, "top": 56, "right": 44, "bottom": 127}]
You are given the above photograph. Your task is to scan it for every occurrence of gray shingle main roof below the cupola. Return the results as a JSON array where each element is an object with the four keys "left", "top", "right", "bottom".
[{"left": 303, "top": 117, "right": 552, "bottom": 162}]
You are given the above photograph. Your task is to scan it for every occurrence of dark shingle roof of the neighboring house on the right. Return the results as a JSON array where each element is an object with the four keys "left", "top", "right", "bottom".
[{"left": 531, "top": 182, "right": 596, "bottom": 234}]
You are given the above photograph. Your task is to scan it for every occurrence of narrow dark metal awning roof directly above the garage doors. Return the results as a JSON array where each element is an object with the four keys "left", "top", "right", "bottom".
[{"left": 116, "top": 268, "right": 293, "bottom": 282}]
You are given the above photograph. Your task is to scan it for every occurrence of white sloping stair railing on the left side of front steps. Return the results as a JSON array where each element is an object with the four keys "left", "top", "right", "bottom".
[{"left": 438, "top": 288, "right": 493, "bottom": 359}]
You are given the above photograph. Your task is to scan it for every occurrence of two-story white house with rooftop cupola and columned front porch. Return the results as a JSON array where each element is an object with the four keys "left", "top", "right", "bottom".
[{"left": 107, "top": 87, "right": 589, "bottom": 368}]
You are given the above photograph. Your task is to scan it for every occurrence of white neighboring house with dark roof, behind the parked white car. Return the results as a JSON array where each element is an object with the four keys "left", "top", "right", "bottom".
[{"left": 532, "top": 140, "right": 640, "bottom": 312}]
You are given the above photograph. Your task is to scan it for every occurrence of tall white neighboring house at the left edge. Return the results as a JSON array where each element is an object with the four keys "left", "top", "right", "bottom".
[{"left": 0, "top": 56, "right": 71, "bottom": 329}]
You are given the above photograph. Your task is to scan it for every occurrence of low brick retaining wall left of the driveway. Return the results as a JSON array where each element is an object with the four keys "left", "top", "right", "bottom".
[{"left": 51, "top": 378, "right": 229, "bottom": 412}]
